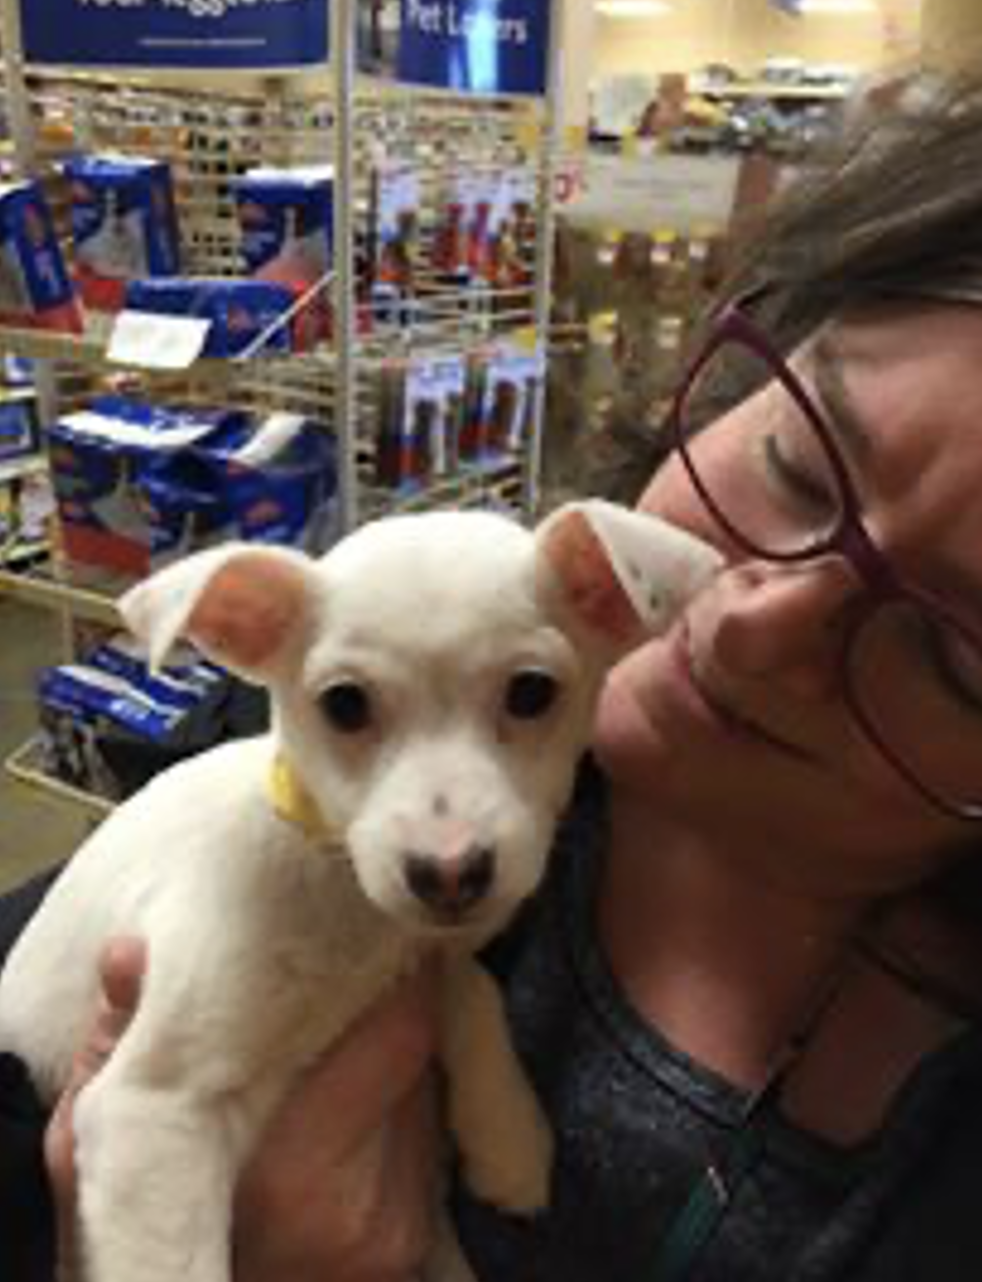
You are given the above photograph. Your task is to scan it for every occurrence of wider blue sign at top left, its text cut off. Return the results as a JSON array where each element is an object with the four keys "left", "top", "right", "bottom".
[{"left": 21, "top": 0, "right": 328, "bottom": 69}]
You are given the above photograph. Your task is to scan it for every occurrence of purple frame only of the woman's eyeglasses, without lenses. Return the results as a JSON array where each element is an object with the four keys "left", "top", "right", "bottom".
[{"left": 667, "top": 290, "right": 982, "bottom": 823}]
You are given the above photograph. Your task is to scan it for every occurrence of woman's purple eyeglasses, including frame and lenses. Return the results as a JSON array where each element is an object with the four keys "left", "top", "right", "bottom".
[{"left": 668, "top": 304, "right": 982, "bottom": 820}]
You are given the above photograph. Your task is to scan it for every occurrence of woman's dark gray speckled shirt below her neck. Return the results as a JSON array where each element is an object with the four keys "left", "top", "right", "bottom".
[{"left": 455, "top": 772, "right": 982, "bottom": 1282}]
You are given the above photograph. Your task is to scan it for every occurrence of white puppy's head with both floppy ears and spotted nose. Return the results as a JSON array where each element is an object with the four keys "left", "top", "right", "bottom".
[{"left": 122, "top": 503, "right": 719, "bottom": 935}]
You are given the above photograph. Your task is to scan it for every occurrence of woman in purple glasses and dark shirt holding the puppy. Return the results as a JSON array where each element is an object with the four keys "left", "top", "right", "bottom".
[{"left": 9, "top": 72, "right": 982, "bottom": 1282}]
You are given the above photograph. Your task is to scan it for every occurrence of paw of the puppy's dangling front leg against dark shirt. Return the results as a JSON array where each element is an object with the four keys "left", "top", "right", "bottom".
[{"left": 464, "top": 1104, "right": 554, "bottom": 1215}]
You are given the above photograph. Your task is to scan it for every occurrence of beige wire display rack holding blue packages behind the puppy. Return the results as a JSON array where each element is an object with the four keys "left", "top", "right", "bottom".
[{"left": 0, "top": 0, "right": 563, "bottom": 815}]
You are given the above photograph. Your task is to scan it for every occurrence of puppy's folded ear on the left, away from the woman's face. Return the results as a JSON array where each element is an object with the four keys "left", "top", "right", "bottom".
[{"left": 119, "top": 544, "right": 319, "bottom": 682}]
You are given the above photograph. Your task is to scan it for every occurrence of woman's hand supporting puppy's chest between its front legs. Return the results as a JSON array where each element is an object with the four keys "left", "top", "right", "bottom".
[{"left": 236, "top": 973, "right": 436, "bottom": 1282}]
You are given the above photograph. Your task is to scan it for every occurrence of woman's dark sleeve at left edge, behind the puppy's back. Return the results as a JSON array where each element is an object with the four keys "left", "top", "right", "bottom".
[{"left": 0, "top": 869, "right": 58, "bottom": 1282}]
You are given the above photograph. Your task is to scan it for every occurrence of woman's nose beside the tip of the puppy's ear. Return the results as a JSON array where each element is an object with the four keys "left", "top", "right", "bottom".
[{"left": 713, "top": 556, "right": 856, "bottom": 699}]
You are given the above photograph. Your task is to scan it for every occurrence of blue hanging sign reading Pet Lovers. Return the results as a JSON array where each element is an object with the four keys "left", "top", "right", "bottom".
[{"left": 399, "top": 0, "right": 550, "bottom": 95}]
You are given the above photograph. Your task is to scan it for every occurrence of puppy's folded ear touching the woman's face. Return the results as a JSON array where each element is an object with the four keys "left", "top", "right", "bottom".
[{"left": 536, "top": 499, "right": 723, "bottom": 662}]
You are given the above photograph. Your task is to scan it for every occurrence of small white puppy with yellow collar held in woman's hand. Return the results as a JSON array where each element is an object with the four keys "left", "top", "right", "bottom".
[{"left": 0, "top": 503, "right": 719, "bottom": 1282}]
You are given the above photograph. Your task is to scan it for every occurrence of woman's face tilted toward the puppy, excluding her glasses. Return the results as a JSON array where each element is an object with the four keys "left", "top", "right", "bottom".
[{"left": 597, "top": 306, "right": 982, "bottom": 888}]
